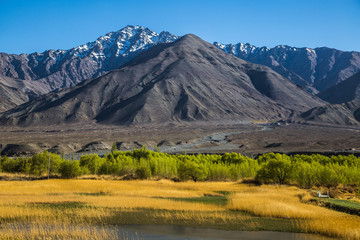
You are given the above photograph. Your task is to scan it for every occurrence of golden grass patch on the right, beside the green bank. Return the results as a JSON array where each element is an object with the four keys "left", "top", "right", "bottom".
[{"left": 228, "top": 186, "right": 360, "bottom": 239}]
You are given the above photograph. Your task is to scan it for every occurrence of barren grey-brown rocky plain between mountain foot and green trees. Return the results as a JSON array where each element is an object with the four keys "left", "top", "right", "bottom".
[{"left": 0, "top": 121, "right": 360, "bottom": 158}]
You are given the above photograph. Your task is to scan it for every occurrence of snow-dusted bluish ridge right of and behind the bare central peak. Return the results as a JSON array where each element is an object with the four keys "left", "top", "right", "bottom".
[{"left": 214, "top": 42, "right": 360, "bottom": 94}]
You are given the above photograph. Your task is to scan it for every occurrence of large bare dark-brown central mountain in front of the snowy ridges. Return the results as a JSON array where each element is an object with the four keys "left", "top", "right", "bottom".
[{"left": 0, "top": 35, "right": 323, "bottom": 125}]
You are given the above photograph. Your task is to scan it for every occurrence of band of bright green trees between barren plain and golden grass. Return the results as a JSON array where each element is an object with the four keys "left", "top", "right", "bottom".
[{"left": 0, "top": 148, "right": 360, "bottom": 188}]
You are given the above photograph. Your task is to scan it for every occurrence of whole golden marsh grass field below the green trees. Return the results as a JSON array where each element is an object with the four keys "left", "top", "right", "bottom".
[{"left": 0, "top": 180, "right": 360, "bottom": 239}]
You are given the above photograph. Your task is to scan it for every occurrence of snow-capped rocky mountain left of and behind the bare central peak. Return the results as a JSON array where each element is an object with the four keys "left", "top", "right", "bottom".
[{"left": 0, "top": 26, "right": 178, "bottom": 109}]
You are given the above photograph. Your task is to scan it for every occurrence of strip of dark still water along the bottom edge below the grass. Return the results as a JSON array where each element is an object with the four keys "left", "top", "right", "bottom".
[{"left": 112, "top": 225, "right": 331, "bottom": 240}]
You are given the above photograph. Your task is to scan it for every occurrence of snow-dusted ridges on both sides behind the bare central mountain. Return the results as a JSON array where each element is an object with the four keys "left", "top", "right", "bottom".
[{"left": 0, "top": 25, "right": 360, "bottom": 113}]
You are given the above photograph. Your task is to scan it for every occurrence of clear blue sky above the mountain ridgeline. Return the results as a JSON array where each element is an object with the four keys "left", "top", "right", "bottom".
[{"left": 0, "top": 0, "right": 360, "bottom": 54}]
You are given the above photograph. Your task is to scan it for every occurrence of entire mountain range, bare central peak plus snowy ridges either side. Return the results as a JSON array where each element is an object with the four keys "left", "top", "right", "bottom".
[{"left": 0, "top": 26, "right": 360, "bottom": 126}]
